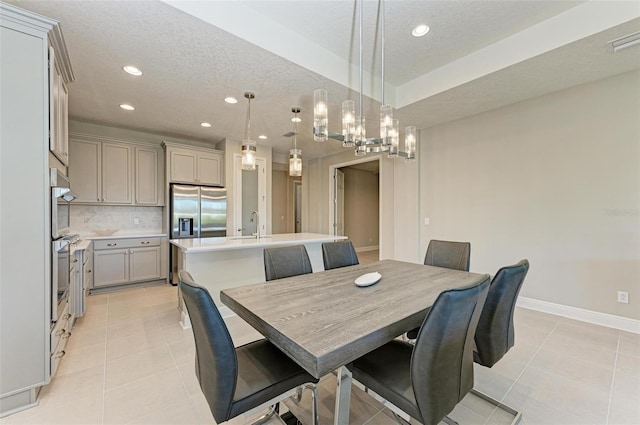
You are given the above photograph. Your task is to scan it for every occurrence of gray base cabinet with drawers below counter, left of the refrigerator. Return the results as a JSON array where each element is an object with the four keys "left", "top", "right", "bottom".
[{"left": 93, "top": 238, "right": 166, "bottom": 288}]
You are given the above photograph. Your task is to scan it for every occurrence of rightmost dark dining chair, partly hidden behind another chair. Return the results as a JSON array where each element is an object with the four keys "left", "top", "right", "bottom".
[{"left": 471, "top": 259, "right": 529, "bottom": 425}]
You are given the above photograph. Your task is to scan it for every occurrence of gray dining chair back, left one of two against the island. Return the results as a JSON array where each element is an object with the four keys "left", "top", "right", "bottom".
[{"left": 264, "top": 245, "right": 313, "bottom": 281}]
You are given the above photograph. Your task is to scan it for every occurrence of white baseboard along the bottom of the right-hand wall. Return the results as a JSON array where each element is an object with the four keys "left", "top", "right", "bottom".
[{"left": 517, "top": 297, "right": 640, "bottom": 334}]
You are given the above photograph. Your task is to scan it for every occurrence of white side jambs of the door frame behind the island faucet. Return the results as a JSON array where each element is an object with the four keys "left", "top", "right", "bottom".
[{"left": 234, "top": 153, "right": 267, "bottom": 236}]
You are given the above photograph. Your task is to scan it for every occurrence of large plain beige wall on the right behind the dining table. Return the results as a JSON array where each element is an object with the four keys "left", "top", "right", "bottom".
[{"left": 419, "top": 71, "right": 640, "bottom": 319}]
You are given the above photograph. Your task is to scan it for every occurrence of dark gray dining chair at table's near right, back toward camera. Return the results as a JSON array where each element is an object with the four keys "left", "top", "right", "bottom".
[{"left": 347, "top": 275, "right": 490, "bottom": 425}]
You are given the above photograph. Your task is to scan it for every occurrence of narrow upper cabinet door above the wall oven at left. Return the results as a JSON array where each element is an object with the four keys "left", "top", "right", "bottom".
[{"left": 49, "top": 45, "right": 69, "bottom": 165}]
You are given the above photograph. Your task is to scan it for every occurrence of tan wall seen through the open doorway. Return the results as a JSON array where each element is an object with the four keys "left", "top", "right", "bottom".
[{"left": 341, "top": 167, "right": 379, "bottom": 249}]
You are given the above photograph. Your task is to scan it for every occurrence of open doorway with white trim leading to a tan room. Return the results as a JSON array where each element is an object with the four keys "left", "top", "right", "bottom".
[{"left": 329, "top": 157, "right": 380, "bottom": 257}]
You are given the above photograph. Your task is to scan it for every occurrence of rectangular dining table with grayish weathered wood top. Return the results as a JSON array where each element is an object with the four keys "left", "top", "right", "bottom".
[{"left": 220, "top": 260, "right": 488, "bottom": 425}]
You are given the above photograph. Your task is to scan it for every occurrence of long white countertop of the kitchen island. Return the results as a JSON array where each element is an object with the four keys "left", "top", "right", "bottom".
[{"left": 169, "top": 233, "right": 347, "bottom": 254}]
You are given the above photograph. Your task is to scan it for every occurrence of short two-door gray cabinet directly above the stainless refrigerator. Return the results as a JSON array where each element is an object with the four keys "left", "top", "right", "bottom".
[{"left": 163, "top": 142, "right": 224, "bottom": 186}]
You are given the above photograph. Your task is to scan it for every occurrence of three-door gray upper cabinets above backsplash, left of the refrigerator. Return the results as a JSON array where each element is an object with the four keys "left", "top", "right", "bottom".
[{"left": 69, "top": 134, "right": 164, "bottom": 206}]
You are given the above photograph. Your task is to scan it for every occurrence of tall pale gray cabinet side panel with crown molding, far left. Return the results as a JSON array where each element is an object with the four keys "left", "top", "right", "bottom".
[{"left": 0, "top": 2, "right": 73, "bottom": 417}]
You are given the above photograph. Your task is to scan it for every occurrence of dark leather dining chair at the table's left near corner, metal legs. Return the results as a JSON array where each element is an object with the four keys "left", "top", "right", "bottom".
[{"left": 178, "top": 270, "right": 318, "bottom": 424}]
